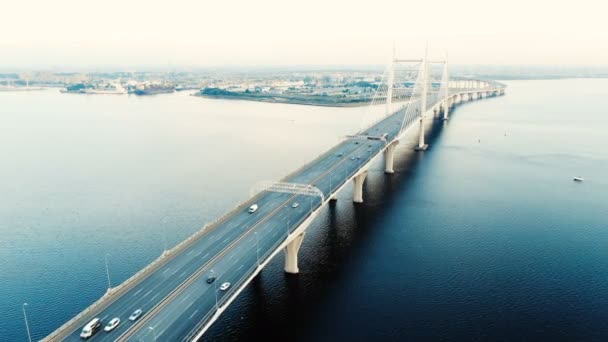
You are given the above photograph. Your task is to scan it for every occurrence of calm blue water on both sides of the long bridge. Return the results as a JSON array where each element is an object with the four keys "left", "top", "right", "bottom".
[{"left": 0, "top": 80, "right": 608, "bottom": 341}]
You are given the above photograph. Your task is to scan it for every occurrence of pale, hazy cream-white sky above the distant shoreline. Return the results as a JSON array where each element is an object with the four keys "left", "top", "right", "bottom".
[{"left": 0, "top": 0, "right": 608, "bottom": 69}]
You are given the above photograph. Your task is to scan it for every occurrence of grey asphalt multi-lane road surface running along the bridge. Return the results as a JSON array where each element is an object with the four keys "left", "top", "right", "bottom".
[{"left": 60, "top": 105, "right": 409, "bottom": 341}]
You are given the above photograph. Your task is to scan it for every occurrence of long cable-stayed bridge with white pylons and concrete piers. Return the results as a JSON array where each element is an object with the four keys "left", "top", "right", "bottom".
[{"left": 44, "top": 50, "right": 505, "bottom": 341}]
